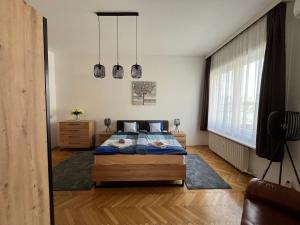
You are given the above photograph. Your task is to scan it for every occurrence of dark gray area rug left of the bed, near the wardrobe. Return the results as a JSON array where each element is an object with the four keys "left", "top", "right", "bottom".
[{"left": 52, "top": 150, "right": 94, "bottom": 191}]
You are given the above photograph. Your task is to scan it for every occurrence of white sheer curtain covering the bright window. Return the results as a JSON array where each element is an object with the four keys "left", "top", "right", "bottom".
[{"left": 208, "top": 18, "right": 267, "bottom": 147}]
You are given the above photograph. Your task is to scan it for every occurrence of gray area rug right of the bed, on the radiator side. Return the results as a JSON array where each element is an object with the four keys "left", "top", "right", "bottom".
[{"left": 185, "top": 154, "right": 231, "bottom": 189}]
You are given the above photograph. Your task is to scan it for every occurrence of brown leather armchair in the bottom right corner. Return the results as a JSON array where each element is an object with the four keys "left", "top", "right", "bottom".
[{"left": 241, "top": 178, "right": 300, "bottom": 225}]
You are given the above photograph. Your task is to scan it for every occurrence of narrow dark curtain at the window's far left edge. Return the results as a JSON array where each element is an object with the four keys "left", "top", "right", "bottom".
[{"left": 200, "top": 57, "right": 211, "bottom": 131}]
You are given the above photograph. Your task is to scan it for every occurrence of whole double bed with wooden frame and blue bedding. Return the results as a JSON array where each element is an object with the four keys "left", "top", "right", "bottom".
[{"left": 92, "top": 120, "right": 186, "bottom": 185}]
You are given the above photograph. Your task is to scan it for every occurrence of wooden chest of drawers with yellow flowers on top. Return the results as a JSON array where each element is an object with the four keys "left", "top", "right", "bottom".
[{"left": 59, "top": 120, "right": 95, "bottom": 148}]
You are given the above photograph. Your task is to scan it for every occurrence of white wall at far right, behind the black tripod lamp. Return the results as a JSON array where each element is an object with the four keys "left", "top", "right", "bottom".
[{"left": 250, "top": 4, "right": 300, "bottom": 190}]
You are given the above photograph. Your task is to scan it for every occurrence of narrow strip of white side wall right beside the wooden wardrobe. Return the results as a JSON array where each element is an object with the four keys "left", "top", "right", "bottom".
[{"left": 48, "top": 51, "right": 58, "bottom": 148}]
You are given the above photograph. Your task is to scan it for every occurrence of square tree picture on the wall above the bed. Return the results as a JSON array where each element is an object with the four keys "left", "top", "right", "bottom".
[{"left": 132, "top": 81, "right": 156, "bottom": 105}]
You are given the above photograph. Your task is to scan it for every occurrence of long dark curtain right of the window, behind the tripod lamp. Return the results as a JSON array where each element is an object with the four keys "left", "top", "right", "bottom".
[{"left": 256, "top": 3, "right": 286, "bottom": 161}]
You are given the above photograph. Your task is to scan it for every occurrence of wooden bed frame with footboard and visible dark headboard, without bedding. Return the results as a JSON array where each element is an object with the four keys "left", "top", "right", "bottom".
[{"left": 92, "top": 120, "right": 186, "bottom": 186}]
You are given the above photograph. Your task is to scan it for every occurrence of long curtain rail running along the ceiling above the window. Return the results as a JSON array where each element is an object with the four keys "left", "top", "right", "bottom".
[{"left": 205, "top": 0, "right": 294, "bottom": 59}]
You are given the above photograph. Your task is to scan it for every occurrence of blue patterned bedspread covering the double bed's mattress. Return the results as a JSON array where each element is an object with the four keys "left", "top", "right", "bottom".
[{"left": 94, "top": 133, "right": 187, "bottom": 155}]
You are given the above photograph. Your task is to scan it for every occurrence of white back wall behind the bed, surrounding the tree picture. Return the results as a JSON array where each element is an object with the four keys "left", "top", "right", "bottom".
[{"left": 55, "top": 54, "right": 207, "bottom": 145}]
